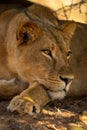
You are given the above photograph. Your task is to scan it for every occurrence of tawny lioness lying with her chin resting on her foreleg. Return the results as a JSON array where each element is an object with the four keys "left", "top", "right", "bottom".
[{"left": 0, "top": 4, "right": 76, "bottom": 114}]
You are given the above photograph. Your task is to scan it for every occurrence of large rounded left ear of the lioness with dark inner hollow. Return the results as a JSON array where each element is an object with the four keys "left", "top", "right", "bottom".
[{"left": 16, "top": 22, "right": 40, "bottom": 45}]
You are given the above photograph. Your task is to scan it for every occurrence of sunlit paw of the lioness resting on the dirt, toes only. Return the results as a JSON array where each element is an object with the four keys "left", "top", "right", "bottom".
[{"left": 7, "top": 95, "right": 40, "bottom": 115}]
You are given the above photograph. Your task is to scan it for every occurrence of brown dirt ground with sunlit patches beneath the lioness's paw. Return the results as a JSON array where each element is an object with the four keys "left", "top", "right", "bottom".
[{"left": 0, "top": 97, "right": 87, "bottom": 130}]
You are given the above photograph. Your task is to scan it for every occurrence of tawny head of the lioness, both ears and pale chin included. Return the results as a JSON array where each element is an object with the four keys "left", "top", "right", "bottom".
[{"left": 6, "top": 12, "right": 76, "bottom": 99}]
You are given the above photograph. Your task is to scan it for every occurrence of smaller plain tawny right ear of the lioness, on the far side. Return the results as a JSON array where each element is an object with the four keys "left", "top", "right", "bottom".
[{"left": 60, "top": 21, "right": 76, "bottom": 39}]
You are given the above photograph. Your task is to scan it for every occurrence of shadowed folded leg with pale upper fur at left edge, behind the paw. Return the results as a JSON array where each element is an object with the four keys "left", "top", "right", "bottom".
[{"left": 0, "top": 78, "right": 29, "bottom": 99}]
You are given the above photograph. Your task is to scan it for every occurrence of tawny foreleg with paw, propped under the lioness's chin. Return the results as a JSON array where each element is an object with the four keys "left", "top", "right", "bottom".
[{"left": 8, "top": 84, "right": 50, "bottom": 115}]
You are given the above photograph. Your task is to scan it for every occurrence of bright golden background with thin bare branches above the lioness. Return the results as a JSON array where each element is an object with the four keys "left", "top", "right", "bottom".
[{"left": 27, "top": 0, "right": 87, "bottom": 24}]
